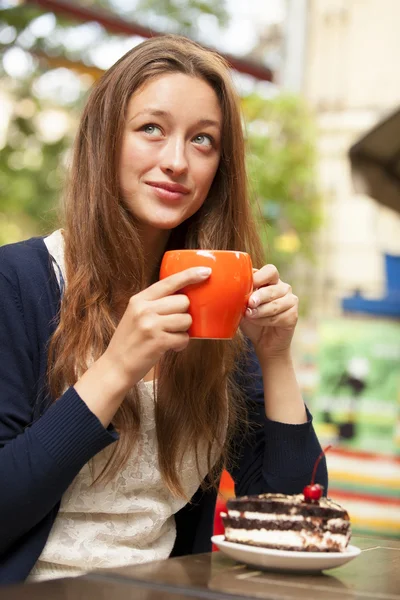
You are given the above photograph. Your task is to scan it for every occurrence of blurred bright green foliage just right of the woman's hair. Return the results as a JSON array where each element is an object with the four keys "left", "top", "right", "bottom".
[{"left": 242, "top": 95, "right": 320, "bottom": 272}]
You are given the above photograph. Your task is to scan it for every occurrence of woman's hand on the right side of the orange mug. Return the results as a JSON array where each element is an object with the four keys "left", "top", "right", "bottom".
[{"left": 240, "top": 265, "right": 299, "bottom": 358}]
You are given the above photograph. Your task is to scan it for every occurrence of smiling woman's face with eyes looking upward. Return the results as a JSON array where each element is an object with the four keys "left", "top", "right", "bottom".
[{"left": 119, "top": 73, "right": 222, "bottom": 230}]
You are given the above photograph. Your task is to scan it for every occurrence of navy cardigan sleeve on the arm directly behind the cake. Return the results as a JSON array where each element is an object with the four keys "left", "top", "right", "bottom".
[{"left": 229, "top": 350, "right": 328, "bottom": 496}]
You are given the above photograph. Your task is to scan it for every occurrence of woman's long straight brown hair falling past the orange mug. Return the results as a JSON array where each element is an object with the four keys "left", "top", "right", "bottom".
[{"left": 49, "top": 35, "right": 262, "bottom": 497}]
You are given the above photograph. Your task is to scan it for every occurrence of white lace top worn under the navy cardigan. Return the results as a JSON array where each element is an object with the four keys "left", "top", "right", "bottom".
[{"left": 29, "top": 231, "right": 216, "bottom": 581}]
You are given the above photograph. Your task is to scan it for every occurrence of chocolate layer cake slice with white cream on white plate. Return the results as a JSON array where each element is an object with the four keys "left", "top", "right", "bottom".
[{"left": 221, "top": 494, "right": 351, "bottom": 552}]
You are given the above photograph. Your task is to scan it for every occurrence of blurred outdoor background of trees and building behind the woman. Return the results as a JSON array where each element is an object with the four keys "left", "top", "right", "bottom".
[{"left": 0, "top": 0, "right": 400, "bottom": 538}]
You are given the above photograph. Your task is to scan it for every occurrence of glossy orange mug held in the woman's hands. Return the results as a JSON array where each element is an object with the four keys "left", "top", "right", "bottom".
[{"left": 160, "top": 250, "right": 253, "bottom": 340}]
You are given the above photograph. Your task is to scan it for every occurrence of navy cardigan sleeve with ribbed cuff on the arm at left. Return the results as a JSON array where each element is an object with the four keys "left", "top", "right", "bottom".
[{"left": 0, "top": 273, "right": 117, "bottom": 562}]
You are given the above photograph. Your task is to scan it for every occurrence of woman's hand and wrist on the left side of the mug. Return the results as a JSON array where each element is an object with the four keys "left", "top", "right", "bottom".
[{"left": 74, "top": 267, "right": 211, "bottom": 426}]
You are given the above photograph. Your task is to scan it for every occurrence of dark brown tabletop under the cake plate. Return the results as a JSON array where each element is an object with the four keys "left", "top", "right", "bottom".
[{"left": 0, "top": 536, "right": 400, "bottom": 600}]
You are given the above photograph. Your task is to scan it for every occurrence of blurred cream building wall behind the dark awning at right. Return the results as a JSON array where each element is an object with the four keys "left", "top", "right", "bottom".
[{"left": 280, "top": 0, "right": 400, "bottom": 316}]
